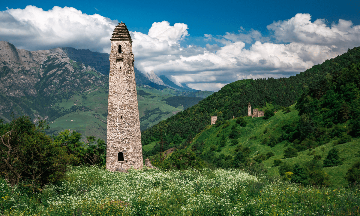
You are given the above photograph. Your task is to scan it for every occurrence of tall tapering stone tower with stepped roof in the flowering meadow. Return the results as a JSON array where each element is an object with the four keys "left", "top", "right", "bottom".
[{"left": 106, "top": 22, "right": 143, "bottom": 172}]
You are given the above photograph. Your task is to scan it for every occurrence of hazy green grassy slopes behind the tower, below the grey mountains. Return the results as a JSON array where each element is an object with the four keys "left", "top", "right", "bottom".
[{"left": 45, "top": 87, "right": 201, "bottom": 140}]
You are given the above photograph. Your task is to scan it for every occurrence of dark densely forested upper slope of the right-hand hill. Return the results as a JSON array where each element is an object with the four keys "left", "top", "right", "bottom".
[{"left": 142, "top": 47, "right": 360, "bottom": 156}]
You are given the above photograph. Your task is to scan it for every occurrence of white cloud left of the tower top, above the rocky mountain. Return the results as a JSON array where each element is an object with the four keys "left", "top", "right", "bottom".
[{"left": 0, "top": 5, "right": 117, "bottom": 52}]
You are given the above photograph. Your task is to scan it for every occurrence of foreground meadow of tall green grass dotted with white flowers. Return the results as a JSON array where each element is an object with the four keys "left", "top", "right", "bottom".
[{"left": 0, "top": 167, "right": 360, "bottom": 215}]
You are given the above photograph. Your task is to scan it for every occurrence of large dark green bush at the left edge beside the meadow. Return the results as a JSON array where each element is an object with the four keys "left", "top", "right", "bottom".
[{"left": 0, "top": 116, "right": 69, "bottom": 192}]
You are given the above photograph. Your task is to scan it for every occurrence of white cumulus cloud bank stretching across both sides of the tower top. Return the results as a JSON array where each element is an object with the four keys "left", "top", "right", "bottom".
[{"left": 0, "top": 6, "right": 360, "bottom": 91}]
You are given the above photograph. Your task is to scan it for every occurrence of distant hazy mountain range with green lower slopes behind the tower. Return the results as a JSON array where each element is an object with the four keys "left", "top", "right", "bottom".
[{"left": 0, "top": 41, "right": 213, "bottom": 139}]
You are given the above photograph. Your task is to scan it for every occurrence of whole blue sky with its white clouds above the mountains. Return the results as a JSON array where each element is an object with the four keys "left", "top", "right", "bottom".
[{"left": 0, "top": 0, "right": 360, "bottom": 91}]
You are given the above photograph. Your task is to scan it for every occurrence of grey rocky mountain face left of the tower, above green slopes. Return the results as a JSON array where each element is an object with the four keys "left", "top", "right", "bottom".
[{"left": 0, "top": 41, "right": 108, "bottom": 120}]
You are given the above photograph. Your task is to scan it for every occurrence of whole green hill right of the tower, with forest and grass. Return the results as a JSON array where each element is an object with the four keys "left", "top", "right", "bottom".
[{"left": 142, "top": 47, "right": 360, "bottom": 186}]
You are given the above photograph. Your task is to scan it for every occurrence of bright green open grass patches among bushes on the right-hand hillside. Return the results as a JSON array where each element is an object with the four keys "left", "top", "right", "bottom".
[{"left": 162, "top": 104, "right": 360, "bottom": 187}]
